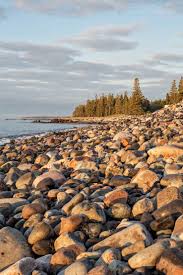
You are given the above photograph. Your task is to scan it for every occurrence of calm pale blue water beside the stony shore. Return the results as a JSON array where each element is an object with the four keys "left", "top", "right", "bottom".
[{"left": 0, "top": 119, "right": 83, "bottom": 144}]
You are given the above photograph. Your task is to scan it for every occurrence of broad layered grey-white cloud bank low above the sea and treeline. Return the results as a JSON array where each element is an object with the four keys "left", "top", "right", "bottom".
[{"left": 0, "top": 39, "right": 181, "bottom": 115}]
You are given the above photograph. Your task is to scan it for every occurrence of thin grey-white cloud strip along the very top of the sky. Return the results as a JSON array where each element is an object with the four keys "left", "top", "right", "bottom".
[{"left": 14, "top": 0, "right": 183, "bottom": 16}]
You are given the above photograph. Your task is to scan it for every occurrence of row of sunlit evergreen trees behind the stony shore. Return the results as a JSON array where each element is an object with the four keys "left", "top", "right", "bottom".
[{"left": 73, "top": 77, "right": 183, "bottom": 117}]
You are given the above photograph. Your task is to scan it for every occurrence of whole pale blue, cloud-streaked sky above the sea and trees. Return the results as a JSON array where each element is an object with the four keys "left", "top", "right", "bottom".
[{"left": 0, "top": 0, "right": 183, "bottom": 117}]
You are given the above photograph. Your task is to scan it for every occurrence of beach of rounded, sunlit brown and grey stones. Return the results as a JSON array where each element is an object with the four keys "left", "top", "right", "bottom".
[{"left": 0, "top": 102, "right": 183, "bottom": 275}]
